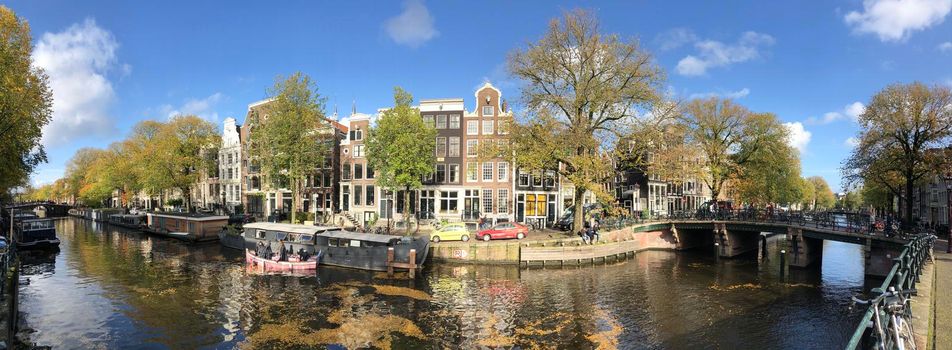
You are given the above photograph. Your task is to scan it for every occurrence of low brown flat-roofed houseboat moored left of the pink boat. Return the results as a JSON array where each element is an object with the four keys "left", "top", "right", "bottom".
[{"left": 146, "top": 213, "right": 228, "bottom": 240}]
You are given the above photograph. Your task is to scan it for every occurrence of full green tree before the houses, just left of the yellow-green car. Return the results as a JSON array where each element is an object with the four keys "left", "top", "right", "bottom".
[{"left": 365, "top": 87, "right": 436, "bottom": 231}]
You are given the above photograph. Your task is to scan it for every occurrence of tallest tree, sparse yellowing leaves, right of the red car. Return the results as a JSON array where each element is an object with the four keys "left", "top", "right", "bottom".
[{"left": 508, "top": 11, "right": 664, "bottom": 227}]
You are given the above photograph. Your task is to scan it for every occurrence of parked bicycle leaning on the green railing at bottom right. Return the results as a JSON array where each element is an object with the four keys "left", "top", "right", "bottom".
[{"left": 853, "top": 287, "right": 916, "bottom": 350}]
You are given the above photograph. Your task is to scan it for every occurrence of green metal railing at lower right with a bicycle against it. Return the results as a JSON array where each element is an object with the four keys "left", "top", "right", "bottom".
[{"left": 846, "top": 235, "right": 935, "bottom": 350}]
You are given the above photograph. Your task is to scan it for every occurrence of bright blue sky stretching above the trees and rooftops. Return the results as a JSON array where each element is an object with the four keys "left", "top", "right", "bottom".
[{"left": 7, "top": 0, "right": 952, "bottom": 189}]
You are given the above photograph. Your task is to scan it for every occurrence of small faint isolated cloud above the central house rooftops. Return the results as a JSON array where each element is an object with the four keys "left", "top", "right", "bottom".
[{"left": 384, "top": 0, "right": 440, "bottom": 48}]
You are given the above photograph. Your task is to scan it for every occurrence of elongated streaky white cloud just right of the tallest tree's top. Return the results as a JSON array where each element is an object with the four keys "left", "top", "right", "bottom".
[{"left": 676, "top": 32, "right": 775, "bottom": 76}]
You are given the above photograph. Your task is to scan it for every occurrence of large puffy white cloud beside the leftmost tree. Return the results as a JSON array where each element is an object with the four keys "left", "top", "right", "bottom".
[{"left": 33, "top": 19, "right": 122, "bottom": 147}]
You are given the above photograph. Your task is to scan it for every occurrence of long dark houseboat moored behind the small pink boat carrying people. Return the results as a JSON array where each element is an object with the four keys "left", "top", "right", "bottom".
[{"left": 233, "top": 222, "right": 430, "bottom": 271}]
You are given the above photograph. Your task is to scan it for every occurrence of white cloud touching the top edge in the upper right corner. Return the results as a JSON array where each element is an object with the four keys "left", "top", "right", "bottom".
[{"left": 843, "top": 0, "right": 952, "bottom": 41}]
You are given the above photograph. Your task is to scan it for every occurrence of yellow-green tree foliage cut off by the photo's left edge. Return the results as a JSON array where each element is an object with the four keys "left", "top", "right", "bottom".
[{"left": 0, "top": 6, "right": 53, "bottom": 196}]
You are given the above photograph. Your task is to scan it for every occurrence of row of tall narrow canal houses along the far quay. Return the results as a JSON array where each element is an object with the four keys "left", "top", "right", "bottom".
[{"left": 141, "top": 83, "right": 709, "bottom": 230}]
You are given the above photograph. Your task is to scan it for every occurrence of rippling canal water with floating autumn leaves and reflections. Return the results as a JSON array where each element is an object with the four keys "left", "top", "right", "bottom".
[{"left": 14, "top": 218, "right": 863, "bottom": 349}]
